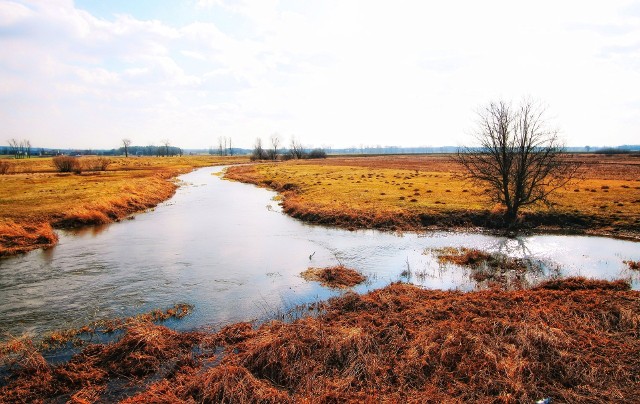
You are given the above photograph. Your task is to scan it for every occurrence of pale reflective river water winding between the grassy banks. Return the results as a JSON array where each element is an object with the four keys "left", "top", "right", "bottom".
[{"left": 0, "top": 167, "right": 640, "bottom": 340}]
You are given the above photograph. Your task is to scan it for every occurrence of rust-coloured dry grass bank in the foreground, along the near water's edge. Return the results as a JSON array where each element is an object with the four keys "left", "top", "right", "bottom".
[{"left": 0, "top": 278, "right": 640, "bottom": 403}]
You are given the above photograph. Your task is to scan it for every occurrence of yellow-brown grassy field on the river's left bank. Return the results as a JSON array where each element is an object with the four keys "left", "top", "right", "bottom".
[{"left": 0, "top": 156, "right": 248, "bottom": 256}]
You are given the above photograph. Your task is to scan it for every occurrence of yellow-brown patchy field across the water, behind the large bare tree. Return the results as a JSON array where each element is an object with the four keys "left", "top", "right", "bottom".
[{"left": 226, "top": 155, "right": 640, "bottom": 239}]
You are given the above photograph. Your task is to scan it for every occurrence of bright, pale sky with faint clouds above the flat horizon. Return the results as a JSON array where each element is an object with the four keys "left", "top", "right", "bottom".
[{"left": 0, "top": 0, "right": 640, "bottom": 149}]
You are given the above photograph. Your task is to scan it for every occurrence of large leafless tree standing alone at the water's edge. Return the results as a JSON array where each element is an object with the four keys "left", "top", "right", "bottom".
[{"left": 457, "top": 100, "right": 579, "bottom": 227}]
